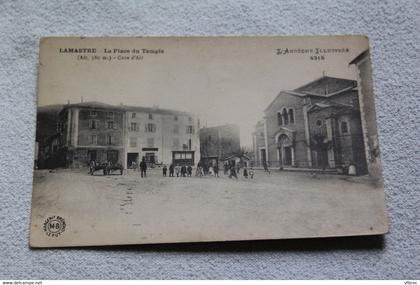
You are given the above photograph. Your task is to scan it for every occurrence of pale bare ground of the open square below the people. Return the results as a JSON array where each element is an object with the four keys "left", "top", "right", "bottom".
[{"left": 31, "top": 169, "right": 387, "bottom": 246}]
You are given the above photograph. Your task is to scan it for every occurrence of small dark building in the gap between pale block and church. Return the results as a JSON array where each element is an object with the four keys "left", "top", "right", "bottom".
[{"left": 200, "top": 124, "right": 241, "bottom": 165}]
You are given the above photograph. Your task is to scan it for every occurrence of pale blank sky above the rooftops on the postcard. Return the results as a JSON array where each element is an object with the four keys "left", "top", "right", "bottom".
[{"left": 38, "top": 36, "right": 368, "bottom": 147}]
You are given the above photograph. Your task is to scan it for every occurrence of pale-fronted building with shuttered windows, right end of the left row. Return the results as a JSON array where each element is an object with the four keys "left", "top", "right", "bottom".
[{"left": 122, "top": 106, "right": 200, "bottom": 168}]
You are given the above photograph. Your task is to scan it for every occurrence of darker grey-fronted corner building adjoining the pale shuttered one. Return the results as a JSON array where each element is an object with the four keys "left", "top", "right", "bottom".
[{"left": 57, "top": 102, "right": 125, "bottom": 168}]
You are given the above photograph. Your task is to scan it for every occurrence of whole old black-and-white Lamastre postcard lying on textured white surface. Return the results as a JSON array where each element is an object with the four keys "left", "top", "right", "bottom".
[{"left": 30, "top": 36, "right": 388, "bottom": 247}]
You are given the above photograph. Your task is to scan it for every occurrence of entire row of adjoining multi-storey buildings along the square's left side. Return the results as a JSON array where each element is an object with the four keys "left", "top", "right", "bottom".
[{"left": 36, "top": 102, "right": 200, "bottom": 168}]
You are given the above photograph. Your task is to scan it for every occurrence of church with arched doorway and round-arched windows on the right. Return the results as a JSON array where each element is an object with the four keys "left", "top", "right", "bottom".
[{"left": 254, "top": 76, "right": 366, "bottom": 173}]
